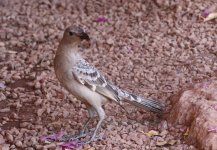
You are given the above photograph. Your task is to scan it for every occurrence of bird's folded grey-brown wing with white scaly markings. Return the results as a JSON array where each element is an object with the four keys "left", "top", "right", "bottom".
[{"left": 72, "top": 59, "right": 120, "bottom": 103}]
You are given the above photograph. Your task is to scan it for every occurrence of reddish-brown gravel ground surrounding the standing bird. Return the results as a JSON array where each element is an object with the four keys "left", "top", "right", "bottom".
[{"left": 0, "top": 0, "right": 217, "bottom": 150}]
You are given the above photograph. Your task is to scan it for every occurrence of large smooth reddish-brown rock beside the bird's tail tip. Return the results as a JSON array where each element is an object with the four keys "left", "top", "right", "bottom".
[{"left": 168, "top": 81, "right": 217, "bottom": 150}]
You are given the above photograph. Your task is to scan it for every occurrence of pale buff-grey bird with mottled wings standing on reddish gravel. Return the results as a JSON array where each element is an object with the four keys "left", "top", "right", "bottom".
[{"left": 54, "top": 25, "right": 164, "bottom": 141}]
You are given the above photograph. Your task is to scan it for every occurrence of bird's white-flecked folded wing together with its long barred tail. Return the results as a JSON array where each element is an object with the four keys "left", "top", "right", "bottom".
[{"left": 73, "top": 58, "right": 163, "bottom": 113}]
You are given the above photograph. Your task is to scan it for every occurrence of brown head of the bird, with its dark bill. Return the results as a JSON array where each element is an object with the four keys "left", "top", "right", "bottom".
[{"left": 63, "top": 26, "right": 90, "bottom": 44}]
